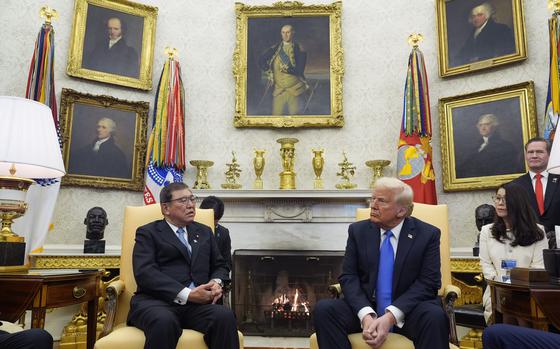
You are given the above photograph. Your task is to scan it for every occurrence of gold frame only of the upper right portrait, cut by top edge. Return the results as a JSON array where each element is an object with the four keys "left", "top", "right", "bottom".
[{"left": 436, "top": 0, "right": 527, "bottom": 77}]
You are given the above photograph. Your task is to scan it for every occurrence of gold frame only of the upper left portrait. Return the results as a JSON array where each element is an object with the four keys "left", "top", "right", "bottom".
[{"left": 66, "top": 0, "right": 158, "bottom": 91}]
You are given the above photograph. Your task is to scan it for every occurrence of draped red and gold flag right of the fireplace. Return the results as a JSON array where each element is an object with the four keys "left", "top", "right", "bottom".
[{"left": 397, "top": 46, "right": 437, "bottom": 205}]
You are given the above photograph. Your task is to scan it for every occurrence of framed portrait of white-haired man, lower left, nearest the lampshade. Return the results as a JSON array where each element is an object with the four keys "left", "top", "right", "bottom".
[{"left": 60, "top": 88, "right": 149, "bottom": 191}]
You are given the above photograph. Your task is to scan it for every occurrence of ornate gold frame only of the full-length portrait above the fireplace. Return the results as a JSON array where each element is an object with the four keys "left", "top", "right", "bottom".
[{"left": 233, "top": 1, "right": 344, "bottom": 128}]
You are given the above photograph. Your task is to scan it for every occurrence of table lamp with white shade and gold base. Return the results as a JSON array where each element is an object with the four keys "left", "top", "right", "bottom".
[{"left": 0, "top": 96, "right": 66, "bottom": 272}]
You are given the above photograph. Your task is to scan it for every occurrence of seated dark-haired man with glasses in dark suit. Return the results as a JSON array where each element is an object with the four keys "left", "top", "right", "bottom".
[{"left": 128, "top": 183, "right": 239, "bottom": 349}]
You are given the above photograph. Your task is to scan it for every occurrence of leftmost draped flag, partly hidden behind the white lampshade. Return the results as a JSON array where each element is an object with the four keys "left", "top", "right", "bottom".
[{"left": 14, "top": 23, "right": 60, "bottom": 256}]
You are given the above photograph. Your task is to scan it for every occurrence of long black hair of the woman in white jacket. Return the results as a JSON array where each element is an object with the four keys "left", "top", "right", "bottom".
[{"left": 492, "top": 183, "right": 545, "bottom": 246}]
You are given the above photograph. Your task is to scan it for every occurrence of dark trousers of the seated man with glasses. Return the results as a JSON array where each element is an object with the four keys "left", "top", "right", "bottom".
[{"left": 131, "top": 303, "right": 239, "bottom": 349}]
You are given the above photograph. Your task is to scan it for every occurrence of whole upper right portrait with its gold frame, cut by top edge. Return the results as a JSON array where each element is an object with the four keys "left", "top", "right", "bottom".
[{"left": 436, "top": 0, "right": 527, "bottom": 77}]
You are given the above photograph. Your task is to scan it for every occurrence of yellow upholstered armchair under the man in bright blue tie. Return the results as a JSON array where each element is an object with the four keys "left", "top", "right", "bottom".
[{"left": 310, "top": 203, "right": 461, "bottom": 349}]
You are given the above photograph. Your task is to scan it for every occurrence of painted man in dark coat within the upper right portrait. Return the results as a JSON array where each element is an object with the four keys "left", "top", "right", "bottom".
[{"left": 457, "top": 2, "right": 515, "bottom": 65}]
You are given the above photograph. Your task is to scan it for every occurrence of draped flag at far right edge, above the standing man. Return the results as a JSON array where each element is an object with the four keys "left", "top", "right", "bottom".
[{"left": 543, "top": 12, "right": 560, "bottom": 142}]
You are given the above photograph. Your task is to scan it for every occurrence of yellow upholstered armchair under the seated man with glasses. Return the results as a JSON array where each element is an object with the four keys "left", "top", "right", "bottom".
[{"left": 95, "top": 204, "right": 243, "bottom": 349}]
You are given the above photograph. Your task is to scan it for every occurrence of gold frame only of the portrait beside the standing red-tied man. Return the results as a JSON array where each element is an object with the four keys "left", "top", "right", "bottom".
[{"left": 439, "top": 81, "right": 537, "bottom": 192}]
